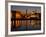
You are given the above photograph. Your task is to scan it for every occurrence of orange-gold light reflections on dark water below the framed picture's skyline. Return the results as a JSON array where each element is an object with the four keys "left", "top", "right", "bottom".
[{"left": 16, "top": 20, "right": 40, "bottom": 26}]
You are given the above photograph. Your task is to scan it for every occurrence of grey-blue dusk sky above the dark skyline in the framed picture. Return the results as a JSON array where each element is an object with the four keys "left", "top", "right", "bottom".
[{"left": 11, "top": 5, "right": 41, "bottom": 14}]
